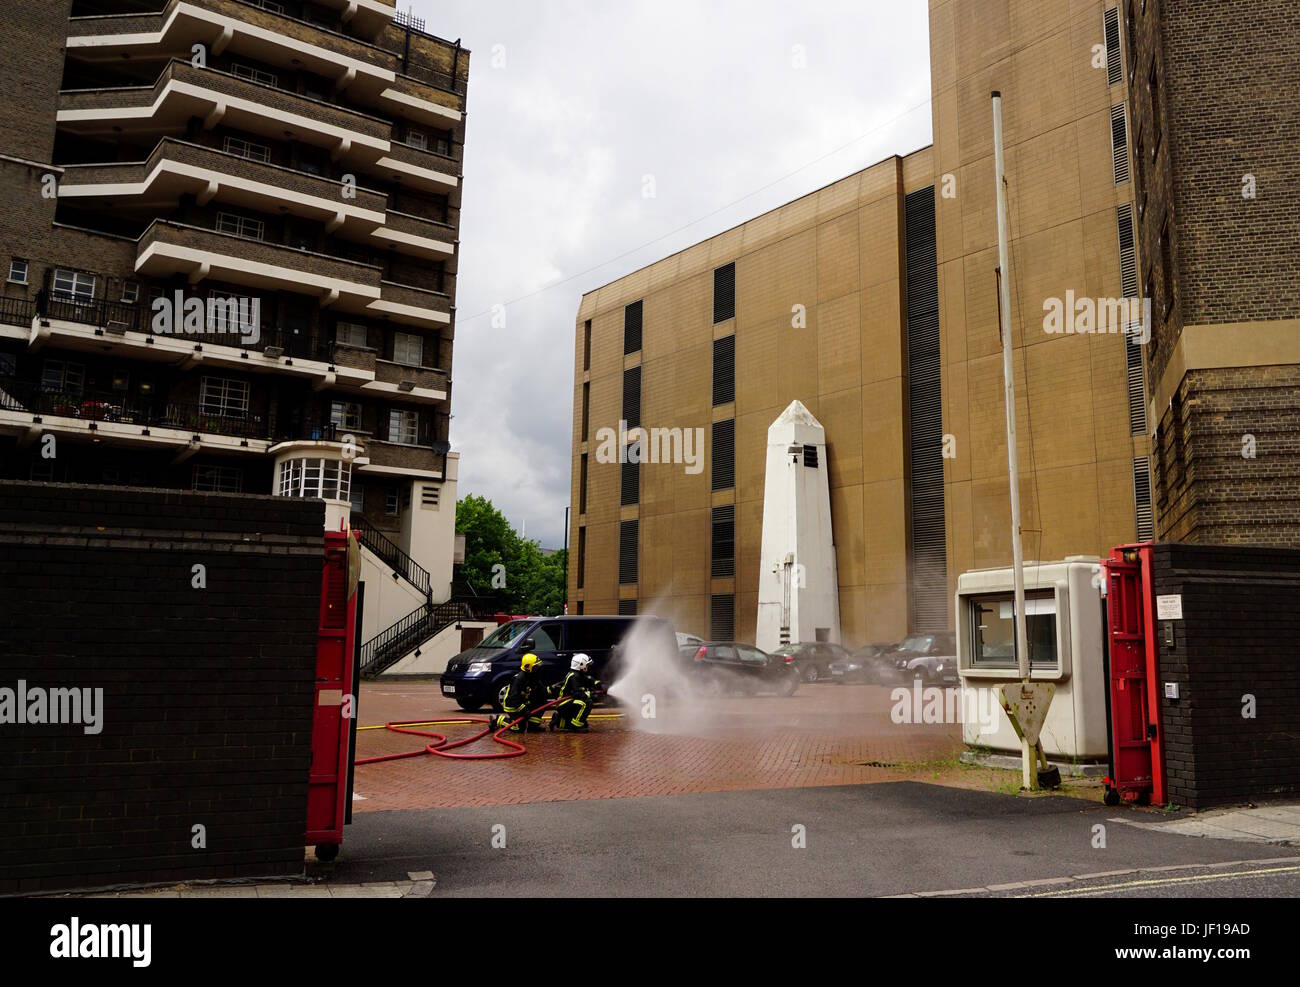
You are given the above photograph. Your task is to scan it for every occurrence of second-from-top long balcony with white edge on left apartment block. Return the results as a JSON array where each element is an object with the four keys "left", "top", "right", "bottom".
[{"left": 56, "top": 58, "right": 391, "bottom": 165}]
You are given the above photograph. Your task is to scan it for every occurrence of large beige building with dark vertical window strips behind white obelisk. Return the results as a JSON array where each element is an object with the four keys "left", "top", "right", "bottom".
[{"left": 569, "top": 0, "right": 1152, "bottom": 645}]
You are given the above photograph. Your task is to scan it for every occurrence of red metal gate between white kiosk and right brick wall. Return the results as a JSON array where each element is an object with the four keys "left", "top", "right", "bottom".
[{"left": 1104, "top": 542, "right": 1165, "bottom": 805}]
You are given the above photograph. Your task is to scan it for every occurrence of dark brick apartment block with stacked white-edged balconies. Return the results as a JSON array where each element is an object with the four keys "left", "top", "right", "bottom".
[{"left": 0, "top": 0, "right": 469, "bottom": 657}]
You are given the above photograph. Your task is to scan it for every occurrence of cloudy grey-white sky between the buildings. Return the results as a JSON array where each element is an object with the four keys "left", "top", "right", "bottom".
[{"left": 410, "top": 0, "right": 931, "bottom": 547}]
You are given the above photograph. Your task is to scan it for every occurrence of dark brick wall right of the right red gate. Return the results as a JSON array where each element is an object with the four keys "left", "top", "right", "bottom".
[{"left": 1154, "top": 542, "right": 1300, "bottom": 809}]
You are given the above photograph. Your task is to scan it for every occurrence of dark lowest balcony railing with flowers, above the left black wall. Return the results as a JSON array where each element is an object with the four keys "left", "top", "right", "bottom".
[{"left": 0, "top": 377, "right": 269, "bottom": 438}]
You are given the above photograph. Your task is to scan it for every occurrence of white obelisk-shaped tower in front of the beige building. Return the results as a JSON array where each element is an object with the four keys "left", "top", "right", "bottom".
[{"left": 754, "top": 401, "right": 840, "bottom": 651}]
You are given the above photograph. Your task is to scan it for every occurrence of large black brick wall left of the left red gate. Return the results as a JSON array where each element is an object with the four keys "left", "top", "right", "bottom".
[{"left": 0, "top": 481, "right": 324, "bottom": 893}]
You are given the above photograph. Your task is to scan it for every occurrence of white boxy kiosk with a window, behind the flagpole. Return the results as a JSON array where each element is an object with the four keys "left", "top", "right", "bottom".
[{"left": 956, "top": 555, "right": 1108, "bottom": 762}]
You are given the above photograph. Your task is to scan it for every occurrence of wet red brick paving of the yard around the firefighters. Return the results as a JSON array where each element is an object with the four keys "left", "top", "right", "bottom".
[{"left": 352, "top": 681, "right": 962, "bottom": 813}]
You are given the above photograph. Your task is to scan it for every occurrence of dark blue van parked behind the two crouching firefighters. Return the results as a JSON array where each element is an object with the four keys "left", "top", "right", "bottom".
[{"left": 442, "top": 616, "right": 676, "bottom": 713}]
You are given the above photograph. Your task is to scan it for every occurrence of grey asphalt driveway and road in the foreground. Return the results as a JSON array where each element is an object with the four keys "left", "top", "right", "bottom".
[{"left": 332, "top": 782, "right": 1300, "bottom": 897}]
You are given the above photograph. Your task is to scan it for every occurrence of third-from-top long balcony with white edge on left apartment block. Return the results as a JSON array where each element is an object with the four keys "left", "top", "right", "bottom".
[{"left": 59, "top": 138, "right": 384, "bottom": 237}]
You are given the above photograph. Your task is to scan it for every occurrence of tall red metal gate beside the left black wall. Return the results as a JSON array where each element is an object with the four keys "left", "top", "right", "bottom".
[{"left": 307, "top": 532, "right": 360, "bottom": 860}]
